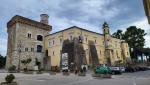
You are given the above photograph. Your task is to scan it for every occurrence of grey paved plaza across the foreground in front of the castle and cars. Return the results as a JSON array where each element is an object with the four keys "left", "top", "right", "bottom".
[{"left": 0, "top": 71, "right": 150, "bottom": 85}]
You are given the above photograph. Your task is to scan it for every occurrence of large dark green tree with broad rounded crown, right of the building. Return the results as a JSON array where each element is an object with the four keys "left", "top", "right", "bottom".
[{"left": 123, "top": 26, "right": 146, "bottom": 59}]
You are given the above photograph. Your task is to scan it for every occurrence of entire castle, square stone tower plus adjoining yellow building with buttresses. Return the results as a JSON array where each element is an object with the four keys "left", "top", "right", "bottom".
[{"left": 6, "top": 14, "right": 130, "bottom": 69}]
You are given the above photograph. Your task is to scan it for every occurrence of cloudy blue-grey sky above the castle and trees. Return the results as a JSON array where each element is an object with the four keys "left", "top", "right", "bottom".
[{"left": 0, "top": 0, "right": 150, "bottom": 55}]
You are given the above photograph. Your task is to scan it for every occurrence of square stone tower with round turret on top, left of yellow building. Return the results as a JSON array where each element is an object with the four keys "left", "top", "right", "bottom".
[{"left": 6, "top": 14, "right": 52, "bottom": 70}]
